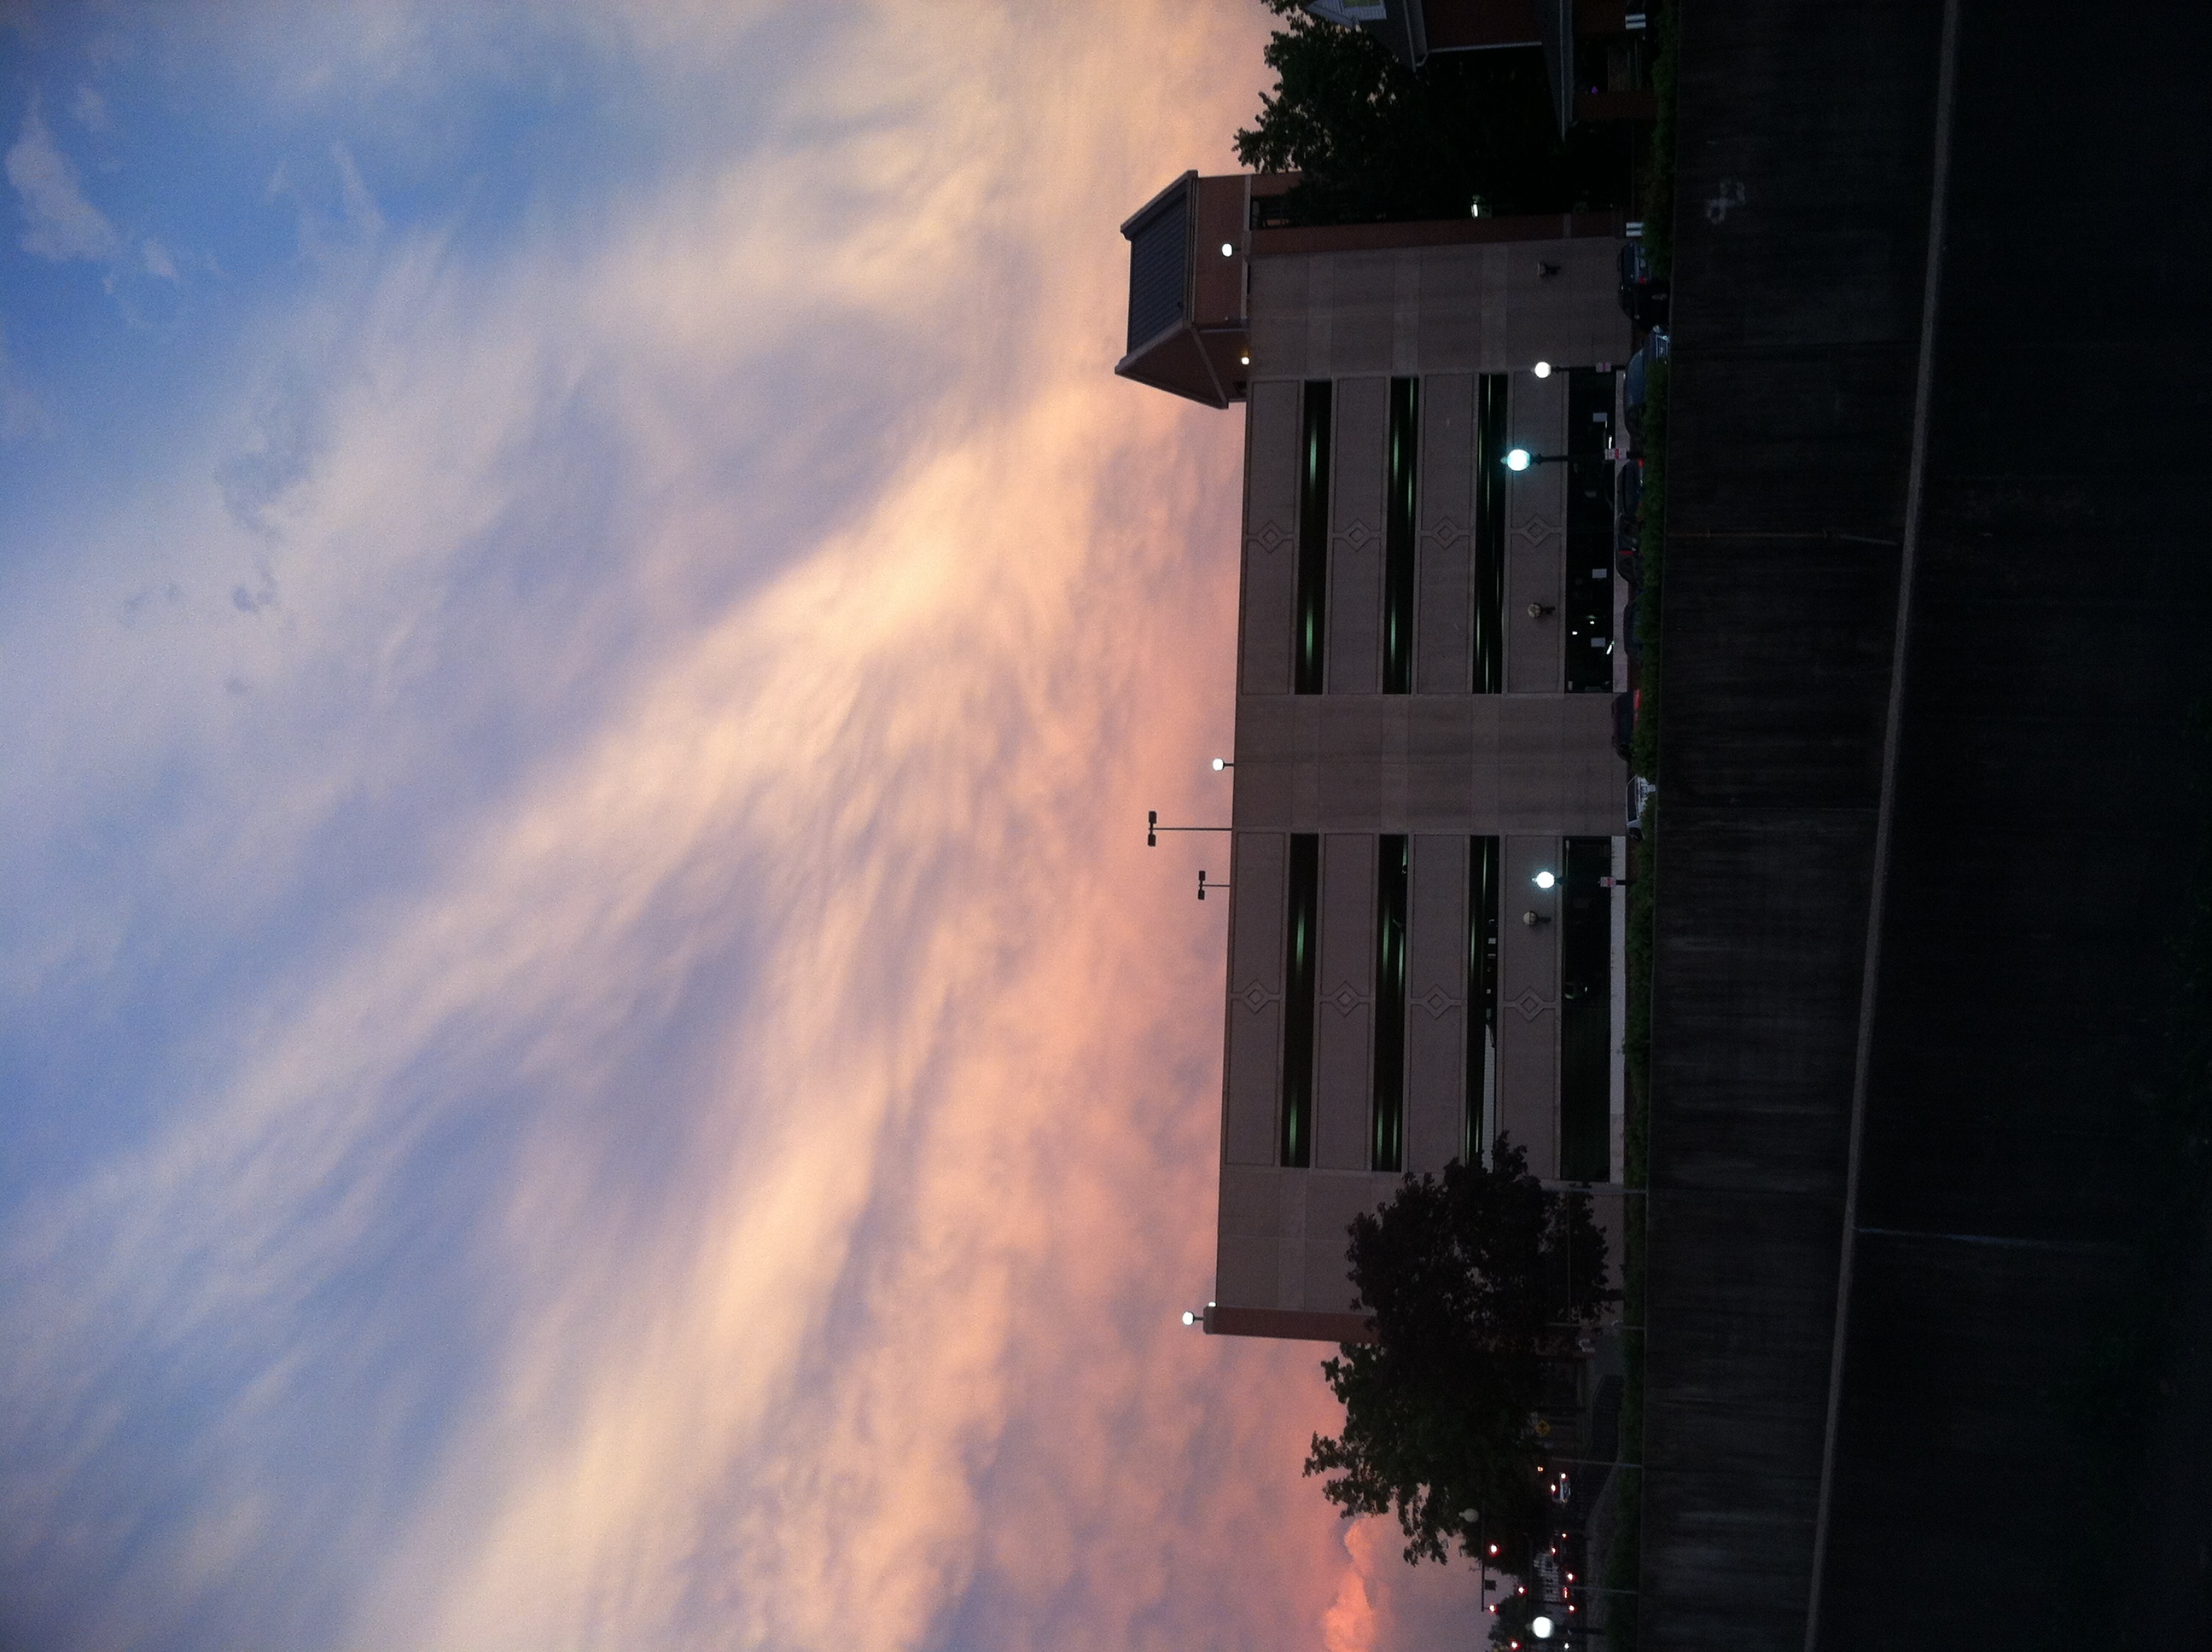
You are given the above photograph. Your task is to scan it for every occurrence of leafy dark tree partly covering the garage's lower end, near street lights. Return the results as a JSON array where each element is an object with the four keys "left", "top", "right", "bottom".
[{"left": 1305, "top": 1137, "right": 1619, "bottom": 1574}]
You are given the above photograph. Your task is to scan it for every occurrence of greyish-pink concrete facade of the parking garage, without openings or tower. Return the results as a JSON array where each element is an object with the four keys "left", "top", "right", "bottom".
[{"left": 1214, "top": 239, "right": 1628, "bottom": 1312}]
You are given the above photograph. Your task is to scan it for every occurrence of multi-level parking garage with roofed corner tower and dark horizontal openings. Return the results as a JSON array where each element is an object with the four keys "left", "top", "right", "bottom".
[{"left": 1115, "top": 172, "right": 1630, "bottom": 1341}]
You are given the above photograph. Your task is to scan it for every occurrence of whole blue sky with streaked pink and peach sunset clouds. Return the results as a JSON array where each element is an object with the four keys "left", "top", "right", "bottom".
[{"left": 0, "top": 0, "right": 1476, "bottom": 1652}]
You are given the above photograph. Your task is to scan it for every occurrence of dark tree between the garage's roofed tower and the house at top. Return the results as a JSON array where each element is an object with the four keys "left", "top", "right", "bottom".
[{"left": 1237, "top": 0, "right": 1630, "bottom": 224}]
